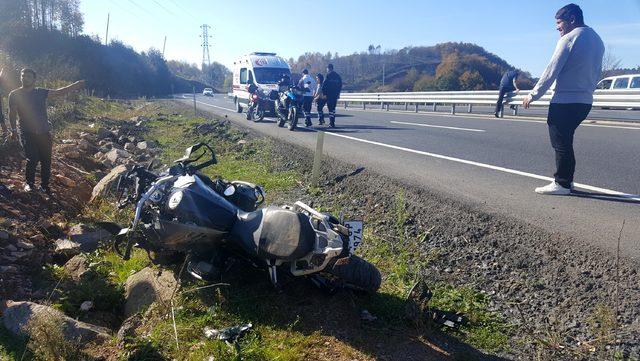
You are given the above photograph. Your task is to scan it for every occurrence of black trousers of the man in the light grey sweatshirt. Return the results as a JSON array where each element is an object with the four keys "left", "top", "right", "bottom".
[{"left": 547, "top": 103, "right": 591, "bottom": 188}]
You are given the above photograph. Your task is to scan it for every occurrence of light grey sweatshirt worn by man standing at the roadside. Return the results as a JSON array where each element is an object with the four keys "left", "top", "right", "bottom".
[{"left": 529, "top": 26, "right": 604, "bottom": 104}]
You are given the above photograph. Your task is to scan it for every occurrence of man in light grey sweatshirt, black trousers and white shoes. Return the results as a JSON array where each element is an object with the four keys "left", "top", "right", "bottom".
[{"left": 522, "top": 4, "right": 604, "bottom": 195}]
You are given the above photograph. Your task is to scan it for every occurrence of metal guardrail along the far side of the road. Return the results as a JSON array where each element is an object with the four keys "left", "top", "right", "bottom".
[{"left": 339, "top": 89, "right": 640, "bottom": 116}]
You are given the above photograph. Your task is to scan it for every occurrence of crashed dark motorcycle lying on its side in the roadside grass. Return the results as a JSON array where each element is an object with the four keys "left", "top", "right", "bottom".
[{"left": 107, "top": 143, "right": 381, "bottom": 292}]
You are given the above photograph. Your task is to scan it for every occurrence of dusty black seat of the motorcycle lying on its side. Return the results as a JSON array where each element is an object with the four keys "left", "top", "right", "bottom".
[{"left": 231, "top": 206, "right": 316, "bottom": 261}]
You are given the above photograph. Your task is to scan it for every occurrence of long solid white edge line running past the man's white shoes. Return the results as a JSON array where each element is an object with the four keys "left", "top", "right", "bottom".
[{"left": 326, "top": 132, "right": 640, "bottom": 202}]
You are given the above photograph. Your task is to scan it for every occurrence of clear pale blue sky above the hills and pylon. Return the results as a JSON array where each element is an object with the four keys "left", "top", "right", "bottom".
[{"left": 81, "top": 0, "right": 640, "bottom": 76}]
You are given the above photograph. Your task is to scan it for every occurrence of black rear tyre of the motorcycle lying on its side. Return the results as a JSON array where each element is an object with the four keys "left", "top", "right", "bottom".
[{"left": 325, "top": 256, "right": 382, "bottom": 293}]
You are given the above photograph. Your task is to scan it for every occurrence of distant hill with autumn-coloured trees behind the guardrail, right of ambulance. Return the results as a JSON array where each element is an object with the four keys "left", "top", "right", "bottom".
[{"left": 290, "top": 42, "right": 533, "bottom": 91}]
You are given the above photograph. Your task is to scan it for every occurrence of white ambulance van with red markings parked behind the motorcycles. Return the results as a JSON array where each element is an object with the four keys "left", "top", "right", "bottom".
[{"left": 233, "top": 53, "right": 291, "bottom": 113}]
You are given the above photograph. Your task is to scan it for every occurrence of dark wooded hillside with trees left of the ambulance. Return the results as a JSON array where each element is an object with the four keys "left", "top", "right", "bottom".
[{"left": 0, "top": 0, "right": 230, "bottom": 97}]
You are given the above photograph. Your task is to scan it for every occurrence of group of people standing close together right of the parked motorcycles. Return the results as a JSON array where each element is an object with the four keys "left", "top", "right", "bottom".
[{"left": 298, "top": 64, "right": 342, "bottom": 128}]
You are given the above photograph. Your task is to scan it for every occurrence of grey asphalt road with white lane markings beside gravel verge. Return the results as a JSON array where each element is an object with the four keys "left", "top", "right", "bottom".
[{"left": 180, "top": 95, "right": 640, "bottom": 260}]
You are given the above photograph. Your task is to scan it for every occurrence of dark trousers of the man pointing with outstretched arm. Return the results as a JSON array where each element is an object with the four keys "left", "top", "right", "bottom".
[{"left": 20, "top": 133, "right": 53, "bottom": 188}]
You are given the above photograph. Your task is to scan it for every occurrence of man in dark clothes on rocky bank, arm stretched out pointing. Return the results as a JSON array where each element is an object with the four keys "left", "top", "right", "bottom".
[{"left": 9, "top": 69, "right": 84, "bottom": 193}]
